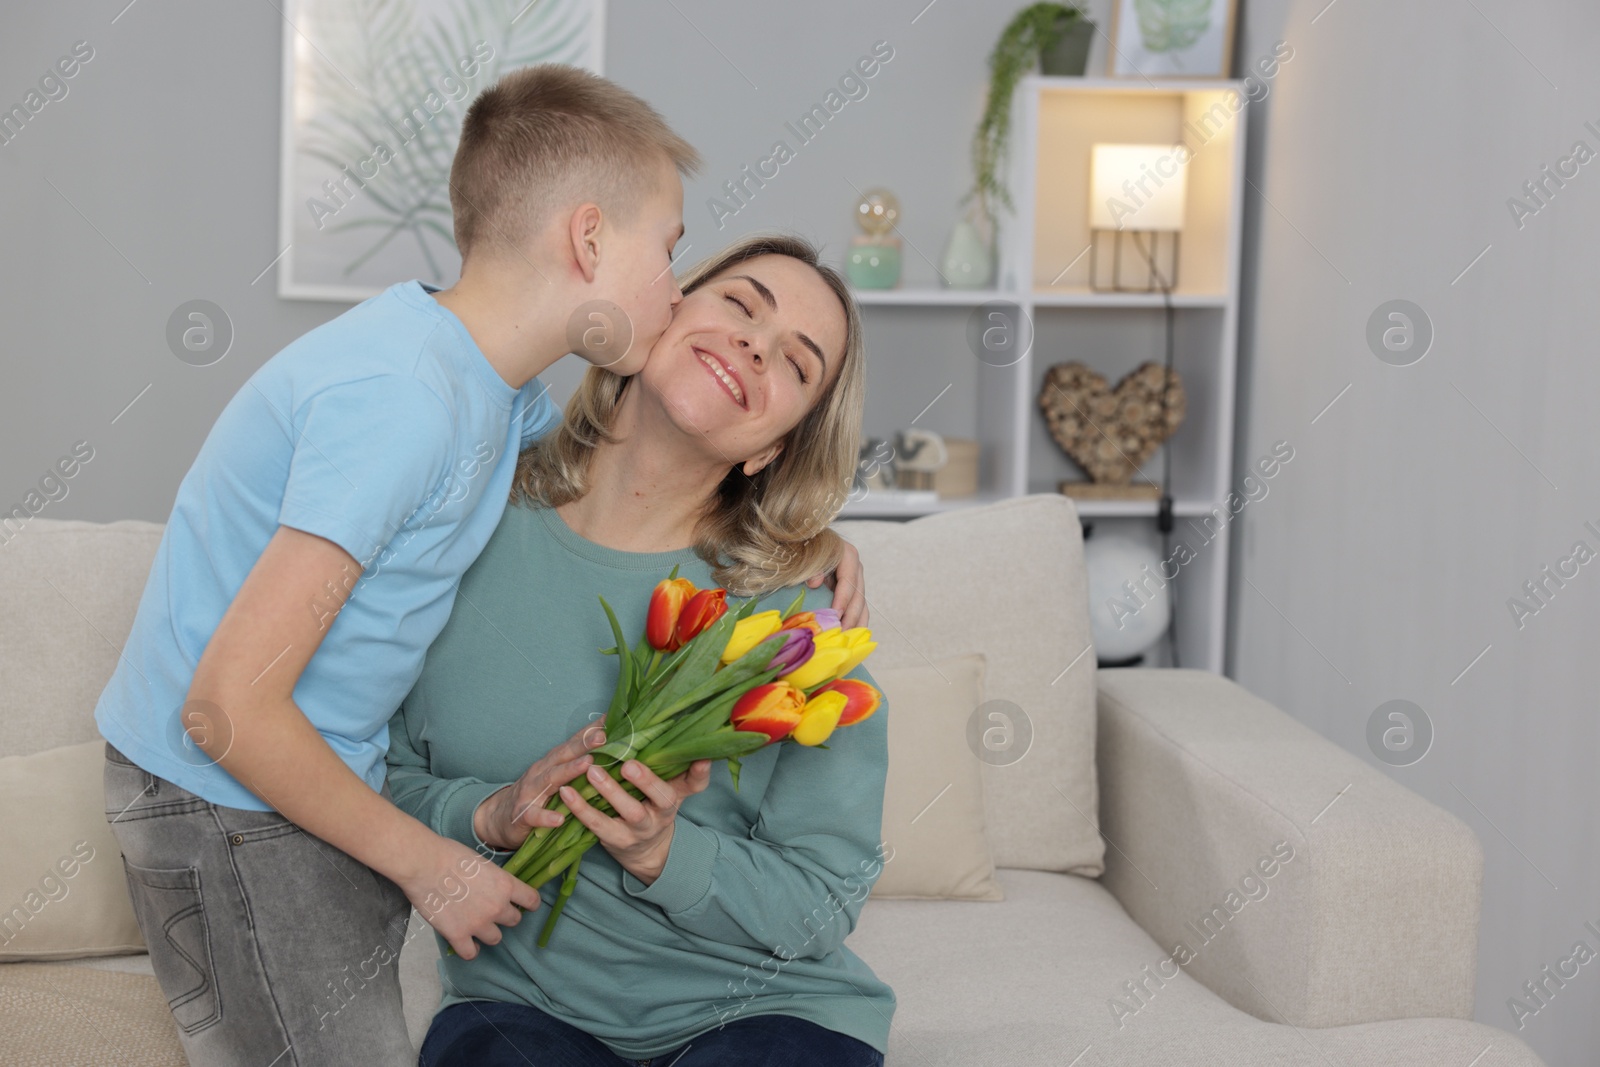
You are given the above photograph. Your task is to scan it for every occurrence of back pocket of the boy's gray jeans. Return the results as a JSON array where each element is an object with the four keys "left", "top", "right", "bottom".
[{"left": 123, "top": 861, "right": 222, "bottom": 1033}]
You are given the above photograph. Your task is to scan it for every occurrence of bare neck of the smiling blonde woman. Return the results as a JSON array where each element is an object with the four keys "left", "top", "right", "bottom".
[{"left": 555, "top": 403, "right": 733, "bottom": 552}]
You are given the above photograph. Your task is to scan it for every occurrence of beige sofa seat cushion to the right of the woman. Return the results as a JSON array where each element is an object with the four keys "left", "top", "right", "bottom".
[{"left": 848, "top": 870, "right": 1539, "bottom": 1067}]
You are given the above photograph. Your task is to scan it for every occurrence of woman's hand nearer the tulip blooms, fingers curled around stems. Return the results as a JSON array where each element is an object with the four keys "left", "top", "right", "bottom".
[{"left": 562, "top": 760, "right": 710, "bottom": 885}]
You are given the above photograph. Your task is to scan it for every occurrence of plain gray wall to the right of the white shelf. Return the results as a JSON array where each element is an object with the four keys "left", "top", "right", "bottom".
[{"left": 1232, "top": 0, "right": 1600, "bottom": 1067}]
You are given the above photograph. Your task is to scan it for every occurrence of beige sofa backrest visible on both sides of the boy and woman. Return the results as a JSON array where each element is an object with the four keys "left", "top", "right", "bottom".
[{"left": 0, "top": 494, "right": 1104, "bottom": 877}]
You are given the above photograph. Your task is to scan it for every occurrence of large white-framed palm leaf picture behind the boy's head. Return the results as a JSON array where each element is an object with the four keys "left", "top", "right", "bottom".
[{"left": 274, "top": 0, "right": 605, "bottom": 302}]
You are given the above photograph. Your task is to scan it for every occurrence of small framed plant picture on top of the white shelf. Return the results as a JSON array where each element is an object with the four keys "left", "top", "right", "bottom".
[{"left": 1110, "top": 0, "right": 1238, "bottom": 78}]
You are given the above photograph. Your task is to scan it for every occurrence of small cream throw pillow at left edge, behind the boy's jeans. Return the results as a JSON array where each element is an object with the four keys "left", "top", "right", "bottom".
[{"left": 0, "top": 741, "right": 144, "bottom": 961}]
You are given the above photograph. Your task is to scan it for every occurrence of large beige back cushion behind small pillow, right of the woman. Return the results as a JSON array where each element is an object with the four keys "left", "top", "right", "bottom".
[{"left": 835, "top": 493, "right": 1104, "bottom": 877}]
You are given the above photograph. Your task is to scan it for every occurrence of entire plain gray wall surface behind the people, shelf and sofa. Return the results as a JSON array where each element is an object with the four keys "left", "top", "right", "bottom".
[{"left": 0, "top": 0, "right": 1600, "bottom": 1067}]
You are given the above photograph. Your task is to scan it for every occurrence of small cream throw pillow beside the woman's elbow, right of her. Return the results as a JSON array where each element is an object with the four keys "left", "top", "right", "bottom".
[{"left": 872, "top": 653, "right": 1005, "bottom": 901}]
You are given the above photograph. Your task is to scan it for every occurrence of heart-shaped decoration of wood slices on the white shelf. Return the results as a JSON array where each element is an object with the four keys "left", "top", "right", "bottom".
[{"left": 1038, "top": 363, "right": 1187, "bottom": 485}]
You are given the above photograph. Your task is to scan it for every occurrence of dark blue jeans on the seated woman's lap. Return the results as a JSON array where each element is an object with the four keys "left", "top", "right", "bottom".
[{"left": 421, "top": 1000, "right": 883, "bottom": 1067}]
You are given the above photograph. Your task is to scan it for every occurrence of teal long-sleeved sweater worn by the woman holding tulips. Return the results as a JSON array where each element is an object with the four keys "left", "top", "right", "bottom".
[{"left": 389, "top": 504, "right": 894, "bottom": 1059}]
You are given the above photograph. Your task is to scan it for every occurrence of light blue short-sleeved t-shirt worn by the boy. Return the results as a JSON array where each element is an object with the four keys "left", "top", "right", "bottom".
[{"left": 94, "top": 280, "right": 558, "bottom": 811}]
